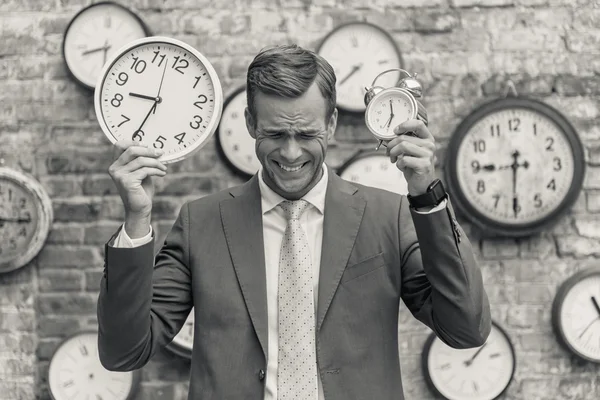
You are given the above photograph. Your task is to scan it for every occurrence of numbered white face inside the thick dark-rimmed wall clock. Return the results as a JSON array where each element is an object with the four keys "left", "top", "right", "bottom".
[{"left": 457, "top": 108, "right": 574, "bottom": 224}]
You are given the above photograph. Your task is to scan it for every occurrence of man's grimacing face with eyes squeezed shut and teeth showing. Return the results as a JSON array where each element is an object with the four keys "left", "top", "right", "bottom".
[{"left": 245, "top": 82, "right": 337, "bottom": 200}]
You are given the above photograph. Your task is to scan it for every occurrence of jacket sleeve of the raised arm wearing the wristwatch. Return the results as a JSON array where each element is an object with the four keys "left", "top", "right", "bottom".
[{"left": 398, "top": 196, "right": 491, "bottom": 348}]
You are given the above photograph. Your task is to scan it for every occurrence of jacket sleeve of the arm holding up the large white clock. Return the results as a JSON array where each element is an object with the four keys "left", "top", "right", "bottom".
[{"left": 97, "top": 203, "right": 192, "bottom": 371}]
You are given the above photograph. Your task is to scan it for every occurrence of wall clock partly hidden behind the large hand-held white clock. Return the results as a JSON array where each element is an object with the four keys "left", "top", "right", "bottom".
[{"left": 62, "top": 1, "right": 150, "bottom": 90}]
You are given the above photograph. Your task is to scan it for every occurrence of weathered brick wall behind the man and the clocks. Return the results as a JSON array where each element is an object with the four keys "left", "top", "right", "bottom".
[{"left": 0, "top": 0, "right": 600, "bottom": 400}]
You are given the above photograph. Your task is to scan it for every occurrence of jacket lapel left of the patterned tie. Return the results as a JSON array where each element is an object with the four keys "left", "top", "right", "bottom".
[{"left": 220, "top": 175, "right": 268, "bottom": 358}]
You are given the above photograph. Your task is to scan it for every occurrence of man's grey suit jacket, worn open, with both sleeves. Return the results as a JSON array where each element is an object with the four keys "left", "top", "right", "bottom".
[{"left": 98, "top": 171, "right": 491, "bottom": 400}]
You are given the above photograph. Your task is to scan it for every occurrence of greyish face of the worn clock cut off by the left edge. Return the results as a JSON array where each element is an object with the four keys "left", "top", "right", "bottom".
[{"left": 0, "top": 179, "right": 38, "bottom": 265}]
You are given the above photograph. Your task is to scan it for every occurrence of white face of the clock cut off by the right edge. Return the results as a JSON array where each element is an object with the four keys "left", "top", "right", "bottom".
[{"left": 560, "top": 274, "right": 600, "bottom": 362}]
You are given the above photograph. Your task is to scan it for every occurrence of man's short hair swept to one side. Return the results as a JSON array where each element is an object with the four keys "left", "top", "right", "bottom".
[{"left": 246, "top": 44, "right": 336, "bottom": 123}]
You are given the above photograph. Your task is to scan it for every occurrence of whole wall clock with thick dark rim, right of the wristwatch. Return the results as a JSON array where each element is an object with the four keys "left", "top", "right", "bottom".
[{"left": 446, "top": 96, "right": 585, "bottom": 237}]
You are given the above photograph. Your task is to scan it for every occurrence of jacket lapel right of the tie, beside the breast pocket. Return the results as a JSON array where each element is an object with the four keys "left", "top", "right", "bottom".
[{"left": 317, "top": 169, "right": 366, "bottom": 330}]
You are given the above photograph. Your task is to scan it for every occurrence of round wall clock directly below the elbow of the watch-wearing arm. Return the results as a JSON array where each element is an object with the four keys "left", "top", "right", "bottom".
[{"left": 421, "top": 323, "right": 516, "bottom": 400}]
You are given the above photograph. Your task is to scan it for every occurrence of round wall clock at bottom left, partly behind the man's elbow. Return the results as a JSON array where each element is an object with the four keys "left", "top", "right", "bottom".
[{"left": 48, "top": 331, "right": 141, "bottom": 400}]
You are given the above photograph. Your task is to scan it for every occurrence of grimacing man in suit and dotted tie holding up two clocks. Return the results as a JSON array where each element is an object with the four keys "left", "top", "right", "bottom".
[{"left": 98, "top": 45, "right": 491, "bottom": 400}]
